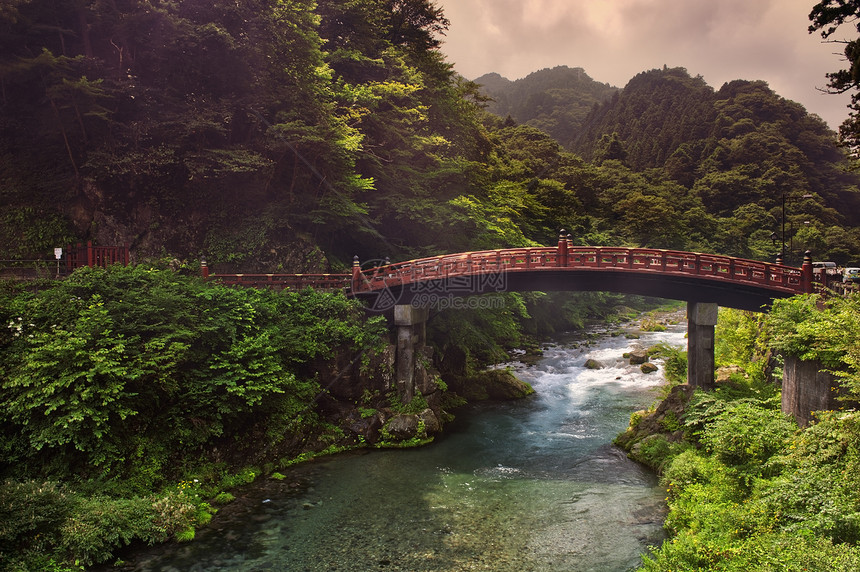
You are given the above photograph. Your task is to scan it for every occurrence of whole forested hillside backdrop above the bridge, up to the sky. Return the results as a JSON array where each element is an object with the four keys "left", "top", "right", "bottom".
[{"left": 0, "top": 0, "right": 860, "bottom": 272}]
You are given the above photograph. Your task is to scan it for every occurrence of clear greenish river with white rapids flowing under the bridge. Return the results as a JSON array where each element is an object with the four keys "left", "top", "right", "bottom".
[{"left": 112, "top": 312, "right": 685, "bottom": 572}]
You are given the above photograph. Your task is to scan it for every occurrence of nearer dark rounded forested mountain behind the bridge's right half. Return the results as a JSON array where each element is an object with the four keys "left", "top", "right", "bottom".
[{"left": 476, "top": 67, "right": 860, "bottom": 262}]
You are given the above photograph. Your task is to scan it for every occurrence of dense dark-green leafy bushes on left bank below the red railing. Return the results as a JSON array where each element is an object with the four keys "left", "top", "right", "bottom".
[{"left": 0, "top": 267, "right": 381, "bottom": 490}]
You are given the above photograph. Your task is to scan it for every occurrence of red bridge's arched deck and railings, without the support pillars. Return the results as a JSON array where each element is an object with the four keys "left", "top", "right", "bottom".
[{"left": 202, "top": 237, "right": 820, "bottom": 311}]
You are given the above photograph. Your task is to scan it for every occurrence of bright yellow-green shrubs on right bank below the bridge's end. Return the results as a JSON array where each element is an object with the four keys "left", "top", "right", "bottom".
[{"left": 642, "top": 297, "right": 860, "bottom": 572}]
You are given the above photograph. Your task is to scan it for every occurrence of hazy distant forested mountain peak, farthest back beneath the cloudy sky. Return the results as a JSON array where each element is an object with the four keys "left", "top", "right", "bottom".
[{"left": 475, "top": 66, "right": 618, "bottom": 147}]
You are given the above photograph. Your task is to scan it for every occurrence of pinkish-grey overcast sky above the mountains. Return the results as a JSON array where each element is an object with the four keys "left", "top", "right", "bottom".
[{"left": 436, "top": 0, "right": 851, "bottom": 129}]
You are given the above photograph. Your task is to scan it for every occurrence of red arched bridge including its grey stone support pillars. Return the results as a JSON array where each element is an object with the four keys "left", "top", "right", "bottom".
[{"left": 207, "top": 237, "right": 829, "bottom": 420}]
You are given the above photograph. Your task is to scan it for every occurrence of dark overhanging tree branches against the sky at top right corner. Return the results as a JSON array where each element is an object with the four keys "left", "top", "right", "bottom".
[{"left": 809, "top": 0, "right": 860, "bottom": 150}]
